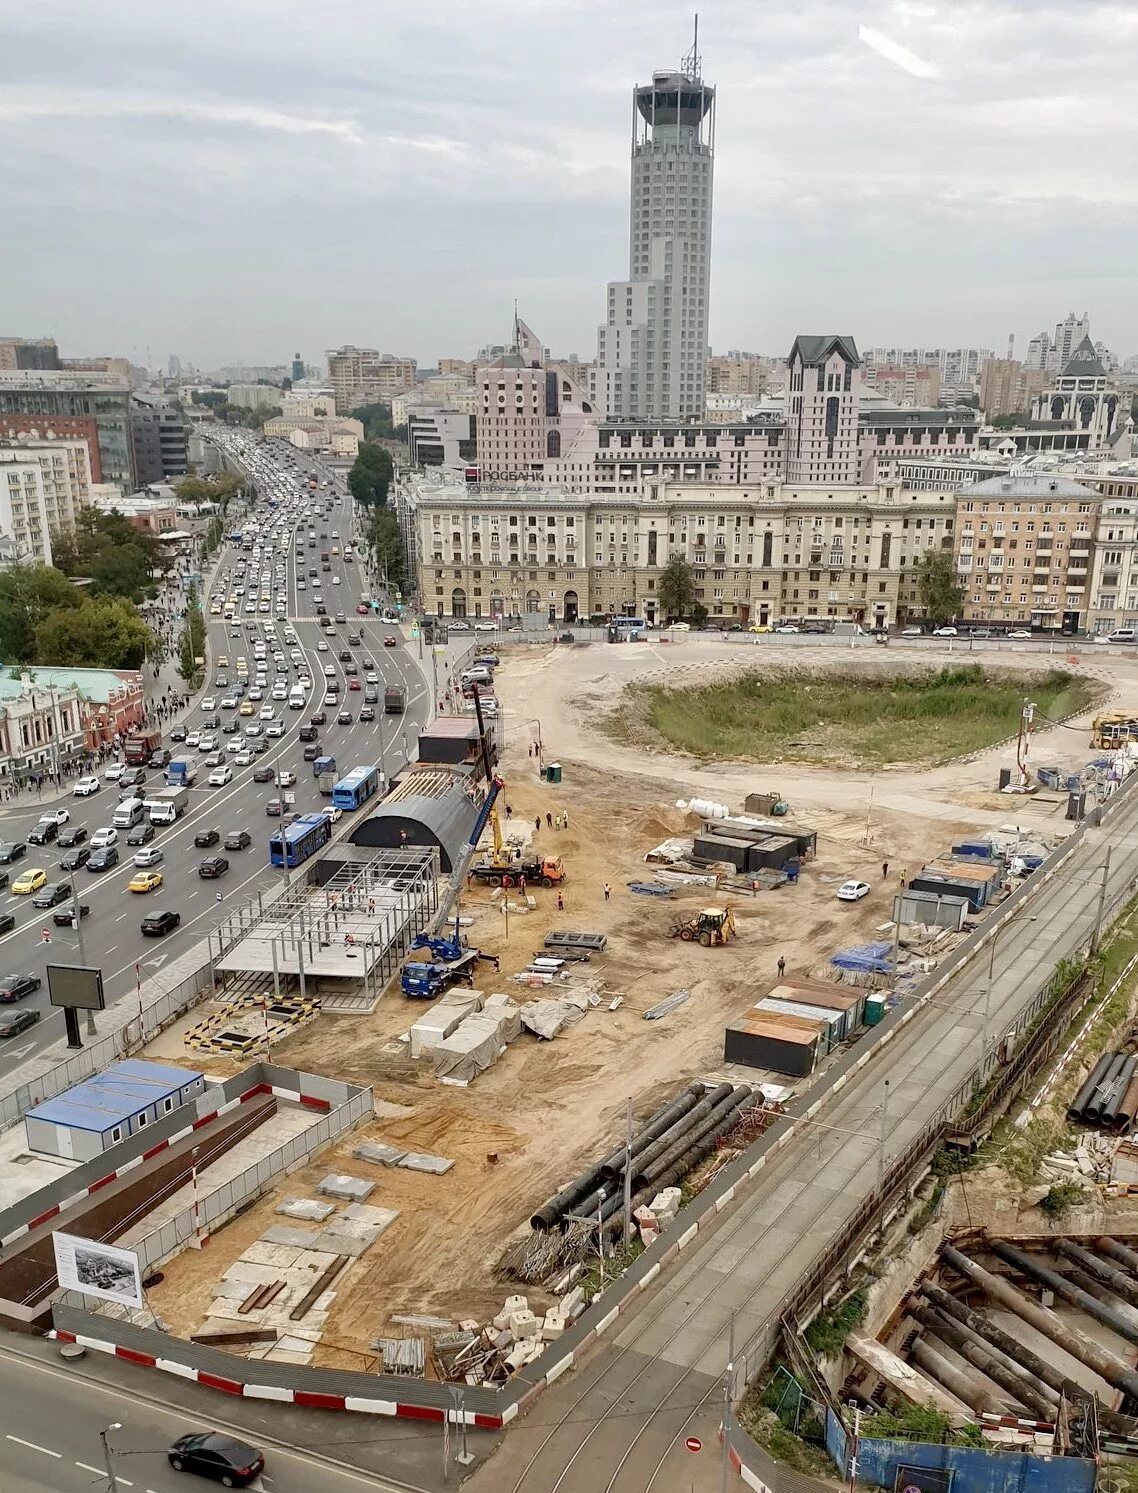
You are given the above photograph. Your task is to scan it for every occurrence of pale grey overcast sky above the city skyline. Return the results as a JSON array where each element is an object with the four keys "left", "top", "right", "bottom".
[{"left": 0, "top": 0, "right": 1138, "bottom": 367}]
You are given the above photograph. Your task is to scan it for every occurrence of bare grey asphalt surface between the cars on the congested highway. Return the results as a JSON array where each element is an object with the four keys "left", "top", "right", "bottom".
[{"left": 0, "top": 448, "right": 442, "bottom": 1072}]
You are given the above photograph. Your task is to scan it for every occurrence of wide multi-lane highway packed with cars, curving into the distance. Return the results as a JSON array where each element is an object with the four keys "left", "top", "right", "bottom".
[{"left": 0, "top": 442, "right": 433, "bottom": 1072}]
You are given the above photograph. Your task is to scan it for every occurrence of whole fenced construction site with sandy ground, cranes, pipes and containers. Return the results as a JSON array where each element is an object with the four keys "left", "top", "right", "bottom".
[{"left": 46, "top": 636, "right": 1134, "bottom": 1403}]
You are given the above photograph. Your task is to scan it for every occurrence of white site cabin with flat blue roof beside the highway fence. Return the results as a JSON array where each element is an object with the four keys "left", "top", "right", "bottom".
[{"left": 24, "top": 1057, "right": 206, "bottom": 1162}]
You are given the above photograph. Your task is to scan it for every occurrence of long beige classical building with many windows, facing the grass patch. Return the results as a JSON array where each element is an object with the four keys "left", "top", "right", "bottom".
[{"left": 397, "top": 479, "right": 956, "bottom": 627}]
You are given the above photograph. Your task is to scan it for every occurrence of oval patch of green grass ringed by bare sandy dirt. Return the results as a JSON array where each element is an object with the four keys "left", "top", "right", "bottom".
[{"left": 609, "top": 664, "right": 1102, "bottom": 766}]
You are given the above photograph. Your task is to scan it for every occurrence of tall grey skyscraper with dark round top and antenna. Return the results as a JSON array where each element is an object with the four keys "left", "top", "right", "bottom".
[{"left": 591, "top": 22, "right": 715, "bottom": 420}]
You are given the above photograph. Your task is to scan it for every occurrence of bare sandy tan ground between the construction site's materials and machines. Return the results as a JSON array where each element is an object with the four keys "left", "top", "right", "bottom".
[{"left": 141, "top": 640, "right": 1138, "bottom": 1368}]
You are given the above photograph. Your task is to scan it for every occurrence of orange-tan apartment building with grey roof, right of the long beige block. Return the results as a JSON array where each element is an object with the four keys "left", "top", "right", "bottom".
[{"left": 956, "top": 472, "right": 1102, "bottom": 633}]
